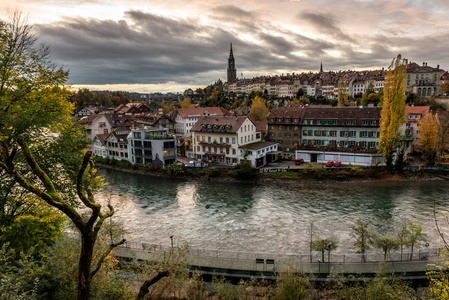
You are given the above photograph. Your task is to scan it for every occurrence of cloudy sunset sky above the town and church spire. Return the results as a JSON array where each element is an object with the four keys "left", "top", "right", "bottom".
[{"left": 0, "top": 0, "right": 449, "bottom": 93}]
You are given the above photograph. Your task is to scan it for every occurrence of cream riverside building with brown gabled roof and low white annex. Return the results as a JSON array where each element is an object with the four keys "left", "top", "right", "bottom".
[{"left": 191, "top": 116, "right": 277, "bottom": 167}]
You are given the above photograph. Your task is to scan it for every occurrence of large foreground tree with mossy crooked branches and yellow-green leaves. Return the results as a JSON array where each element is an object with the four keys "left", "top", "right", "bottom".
[{"left": 0, "top": 12, "right": 124, "bottom": 299}]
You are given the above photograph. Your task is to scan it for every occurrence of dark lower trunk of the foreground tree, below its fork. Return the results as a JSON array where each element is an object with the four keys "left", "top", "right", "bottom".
[{"left": 77, "top": 234, "right": 95, "bottom": 300}]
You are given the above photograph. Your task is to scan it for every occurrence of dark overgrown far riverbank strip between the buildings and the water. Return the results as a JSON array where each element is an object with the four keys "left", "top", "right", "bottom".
[{"left": 95, "top": 158, "right": 449, "bottom": 184}]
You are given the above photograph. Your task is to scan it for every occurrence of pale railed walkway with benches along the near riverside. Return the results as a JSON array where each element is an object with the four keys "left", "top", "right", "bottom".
[{"left": 115, "top": 243, "right": 445, "bottom": 279}]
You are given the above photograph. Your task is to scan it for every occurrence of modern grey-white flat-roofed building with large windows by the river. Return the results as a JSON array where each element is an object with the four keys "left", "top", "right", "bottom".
[{"left": 127, "top": 127, "right": 176, "bottom": 169}]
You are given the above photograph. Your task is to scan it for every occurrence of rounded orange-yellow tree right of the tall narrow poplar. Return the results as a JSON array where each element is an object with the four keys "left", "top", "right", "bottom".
[{"left": 418, "top": 113, "right": 442, "bottom": 165}]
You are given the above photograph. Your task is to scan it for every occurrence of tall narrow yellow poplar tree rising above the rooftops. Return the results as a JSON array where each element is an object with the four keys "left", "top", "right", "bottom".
[{"left": 379, "top": 54, "right": 407, "bottom": 168}]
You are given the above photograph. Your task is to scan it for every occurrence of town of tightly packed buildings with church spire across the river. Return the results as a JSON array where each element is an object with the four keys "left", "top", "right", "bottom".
[{"left": 75, "top": 44, "right": 449, "bottom": 168}]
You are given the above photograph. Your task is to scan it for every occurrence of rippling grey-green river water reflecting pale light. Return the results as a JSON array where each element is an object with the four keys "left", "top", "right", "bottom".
[{"left": 97, "top": 169, "right": 449, "bottom": 253}]
